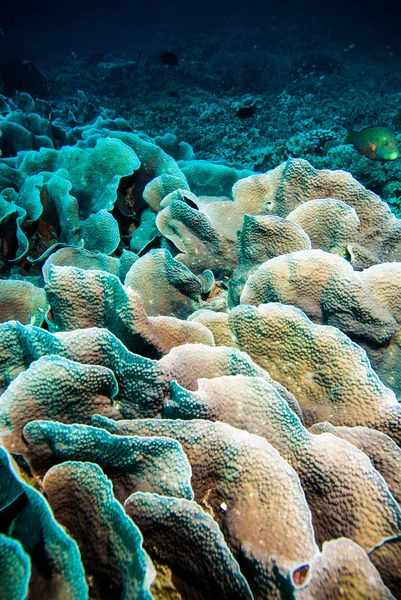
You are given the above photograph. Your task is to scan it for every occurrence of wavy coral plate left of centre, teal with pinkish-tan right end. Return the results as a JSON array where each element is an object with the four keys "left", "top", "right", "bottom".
[{"left": 46, "top": 267, "right": 214, "bottom": 358}]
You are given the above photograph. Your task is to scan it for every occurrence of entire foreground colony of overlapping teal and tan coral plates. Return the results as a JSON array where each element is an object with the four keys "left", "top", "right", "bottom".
[{"left": 0, "top": 85, "right": 401, "bottom": 600}]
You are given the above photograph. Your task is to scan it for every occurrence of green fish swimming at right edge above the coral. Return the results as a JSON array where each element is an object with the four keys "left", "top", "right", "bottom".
[{"left": 343, "top": 127, "right": 400, "bottom": 160}]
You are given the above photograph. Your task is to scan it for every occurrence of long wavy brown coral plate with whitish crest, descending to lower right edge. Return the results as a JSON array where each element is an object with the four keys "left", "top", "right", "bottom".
[{"left": 163, "top": 375, "right": 401, "bottom": 592}]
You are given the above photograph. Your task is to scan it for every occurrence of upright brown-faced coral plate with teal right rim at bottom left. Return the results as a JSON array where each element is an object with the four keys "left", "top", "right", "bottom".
[{"left": 43, "top": 462, "right": 154, "bottom": 600}]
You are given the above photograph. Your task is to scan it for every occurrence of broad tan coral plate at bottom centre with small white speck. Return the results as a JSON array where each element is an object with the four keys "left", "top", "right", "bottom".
[{"left": 93, "top": 417, "right": 317, "bottom": 598}]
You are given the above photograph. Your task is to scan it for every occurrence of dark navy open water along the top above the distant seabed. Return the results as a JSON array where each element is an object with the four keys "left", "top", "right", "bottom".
[{"left": 0, "top": 0, "right": 400, "bottom": 60}]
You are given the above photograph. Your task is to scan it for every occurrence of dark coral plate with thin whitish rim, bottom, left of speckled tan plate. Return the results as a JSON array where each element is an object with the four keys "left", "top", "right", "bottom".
[{"left": 124, "top": 492, "right": 252, "bottom": 600}]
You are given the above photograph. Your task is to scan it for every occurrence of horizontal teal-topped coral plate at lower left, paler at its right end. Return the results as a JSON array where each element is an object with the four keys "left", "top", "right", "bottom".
[{"left": 24, "top": 421, "right": 193, "bottom": 503}]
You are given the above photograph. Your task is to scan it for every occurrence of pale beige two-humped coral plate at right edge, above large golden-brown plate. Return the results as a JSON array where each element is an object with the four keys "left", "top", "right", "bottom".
[{"left": 240, "top": 250, "right": 401, "bottom": 393}]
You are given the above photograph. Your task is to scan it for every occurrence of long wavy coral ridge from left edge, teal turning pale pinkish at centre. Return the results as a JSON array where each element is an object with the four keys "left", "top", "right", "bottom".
[{"left": 0, "top": 322, "right": 301, "bottom": 418}]
